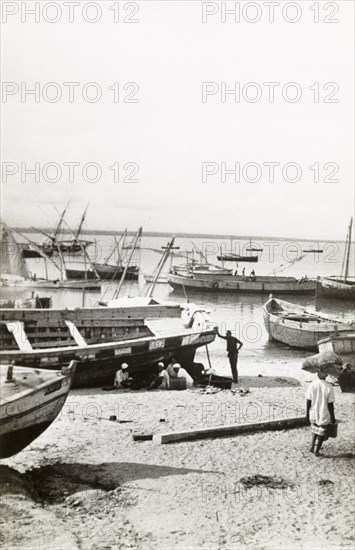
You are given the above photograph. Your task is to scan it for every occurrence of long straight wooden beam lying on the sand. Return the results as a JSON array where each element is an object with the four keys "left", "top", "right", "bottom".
[{"left": 153, "top": 417, "right": 308, "bottom": 444}]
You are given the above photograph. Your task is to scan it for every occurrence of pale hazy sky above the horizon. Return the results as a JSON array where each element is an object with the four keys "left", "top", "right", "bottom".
[{"left": 2, "top": 0, "right": 354, "bottom": 239}]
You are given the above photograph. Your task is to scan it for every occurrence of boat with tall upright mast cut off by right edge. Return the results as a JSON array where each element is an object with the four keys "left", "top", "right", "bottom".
[{"left": 317, "top": 218, "right": 355, "bottom": 303}]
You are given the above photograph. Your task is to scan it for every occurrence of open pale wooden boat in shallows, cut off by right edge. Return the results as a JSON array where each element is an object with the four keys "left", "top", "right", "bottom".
[{"left": 264, "top": 297, "right": 355, "bottom": 350}]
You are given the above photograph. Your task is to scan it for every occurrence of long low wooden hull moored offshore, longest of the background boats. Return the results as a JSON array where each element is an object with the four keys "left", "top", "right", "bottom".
[{"left": 168, "top": 274, "right": 317, "bottom": 294}]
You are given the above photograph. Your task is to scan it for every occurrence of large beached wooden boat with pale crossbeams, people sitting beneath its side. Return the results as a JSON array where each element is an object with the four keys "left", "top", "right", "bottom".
[{"left": 0, "top": 297, "right": 216, "bottom": 386}]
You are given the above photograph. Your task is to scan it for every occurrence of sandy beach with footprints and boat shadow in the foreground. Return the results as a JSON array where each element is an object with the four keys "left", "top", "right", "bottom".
[{"left": 0, "top": 356, "right": 355, "bottom": 550}]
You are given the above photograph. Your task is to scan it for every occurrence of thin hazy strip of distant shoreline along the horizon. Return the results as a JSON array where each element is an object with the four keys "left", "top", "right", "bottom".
[{"left": 14, "top": 227, "right": 345, "bottom": 243}]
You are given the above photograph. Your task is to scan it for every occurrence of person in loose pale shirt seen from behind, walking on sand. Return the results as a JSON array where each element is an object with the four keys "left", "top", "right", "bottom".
[{"left": 306, "top": 369, "right": 335, "bottom": 456}]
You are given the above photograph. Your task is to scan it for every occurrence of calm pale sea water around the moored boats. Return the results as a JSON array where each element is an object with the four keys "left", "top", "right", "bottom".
[{"left": 2, "top": 235, "right": 355, "bottom": 375}]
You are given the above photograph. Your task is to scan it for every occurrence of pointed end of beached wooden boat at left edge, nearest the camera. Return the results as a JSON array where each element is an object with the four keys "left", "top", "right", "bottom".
[{"left": 0, "top": 364, "right": 75, "bottom": 458}]
